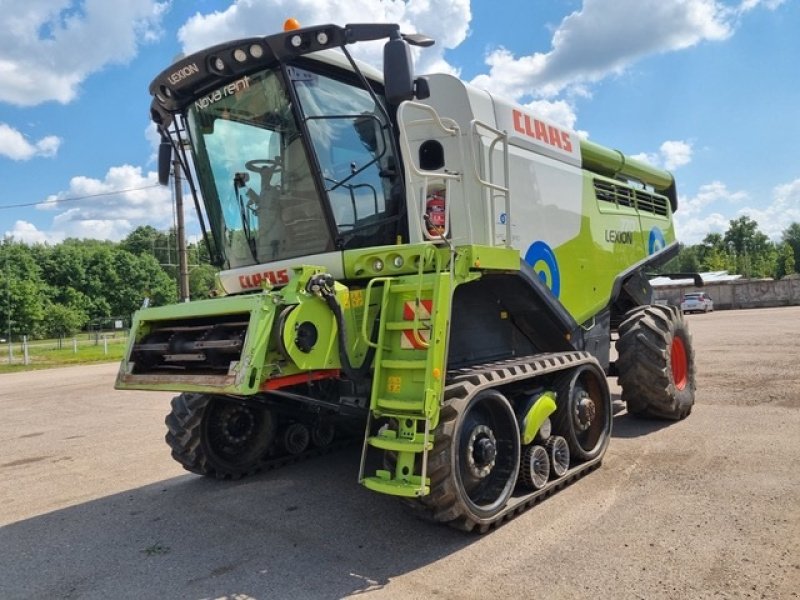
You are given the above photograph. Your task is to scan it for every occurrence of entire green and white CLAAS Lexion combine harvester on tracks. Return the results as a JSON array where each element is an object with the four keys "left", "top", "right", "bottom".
[{"left": 116, "top": 24, "right": 695, "bottom": 531}]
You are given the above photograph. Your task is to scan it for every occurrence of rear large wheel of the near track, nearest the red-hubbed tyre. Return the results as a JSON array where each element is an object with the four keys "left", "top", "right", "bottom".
[{"left": 551, "top": 364, "right": 612, "bottom": 461}]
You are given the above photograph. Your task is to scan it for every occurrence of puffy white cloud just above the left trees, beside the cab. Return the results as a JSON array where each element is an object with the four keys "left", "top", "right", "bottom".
[{"left": 14, "top": 165, "right": 177, "bottom": 243}]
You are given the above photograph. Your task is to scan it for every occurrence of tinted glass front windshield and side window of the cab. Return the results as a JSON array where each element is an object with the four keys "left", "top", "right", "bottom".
[{"left": 187, "top": 62, "right": 400, "bottom": 268}]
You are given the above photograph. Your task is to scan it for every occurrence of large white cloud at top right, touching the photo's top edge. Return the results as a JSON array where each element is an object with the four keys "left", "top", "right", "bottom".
[{"left": 473, "top": 0, "right": 782, "bottom": 99}]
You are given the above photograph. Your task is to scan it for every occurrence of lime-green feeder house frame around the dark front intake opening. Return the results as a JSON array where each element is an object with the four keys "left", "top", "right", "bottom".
[{"left": 116, "top": 266, "right": 375, "bottom": 396}]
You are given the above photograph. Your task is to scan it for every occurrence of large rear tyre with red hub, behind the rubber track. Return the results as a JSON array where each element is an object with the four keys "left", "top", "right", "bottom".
[{"left": 617, "top": 304, "right": 696, "bottom": 420}]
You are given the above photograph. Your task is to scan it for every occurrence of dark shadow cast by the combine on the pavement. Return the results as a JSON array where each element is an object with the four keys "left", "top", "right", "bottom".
[{"left": 0, "top": 449, "right": 479, "bottom": 600}]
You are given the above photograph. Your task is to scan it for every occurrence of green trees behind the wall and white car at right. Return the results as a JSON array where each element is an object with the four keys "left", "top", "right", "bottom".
[{"left": 659, "top": 216, "right": 800, "bottom": 279}]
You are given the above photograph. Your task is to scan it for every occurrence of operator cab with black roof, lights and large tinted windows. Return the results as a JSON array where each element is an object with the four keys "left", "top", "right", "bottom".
[{"left": 150, "top": 25, "right": 428, "bottom": 283}]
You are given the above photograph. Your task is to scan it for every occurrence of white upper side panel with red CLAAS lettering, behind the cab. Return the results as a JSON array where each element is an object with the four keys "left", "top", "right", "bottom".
[{"left": 401, "top": 75, "right": 583, "bottom": 256}]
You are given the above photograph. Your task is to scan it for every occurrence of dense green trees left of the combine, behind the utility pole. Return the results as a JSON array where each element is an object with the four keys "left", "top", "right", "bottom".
[{"left": 0, "top": 226, "right": 216, "bottom": 339}]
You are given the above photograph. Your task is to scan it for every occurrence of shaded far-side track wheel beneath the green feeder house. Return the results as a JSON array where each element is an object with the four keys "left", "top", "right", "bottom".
[{"left": 165, "top": 393, "right": 276, "bottom": 479}]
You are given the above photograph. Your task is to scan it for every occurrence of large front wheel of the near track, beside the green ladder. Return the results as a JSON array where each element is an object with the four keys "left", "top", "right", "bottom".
[{"left": 418, "top": 390, "right": 520, "bottom": 530}]
